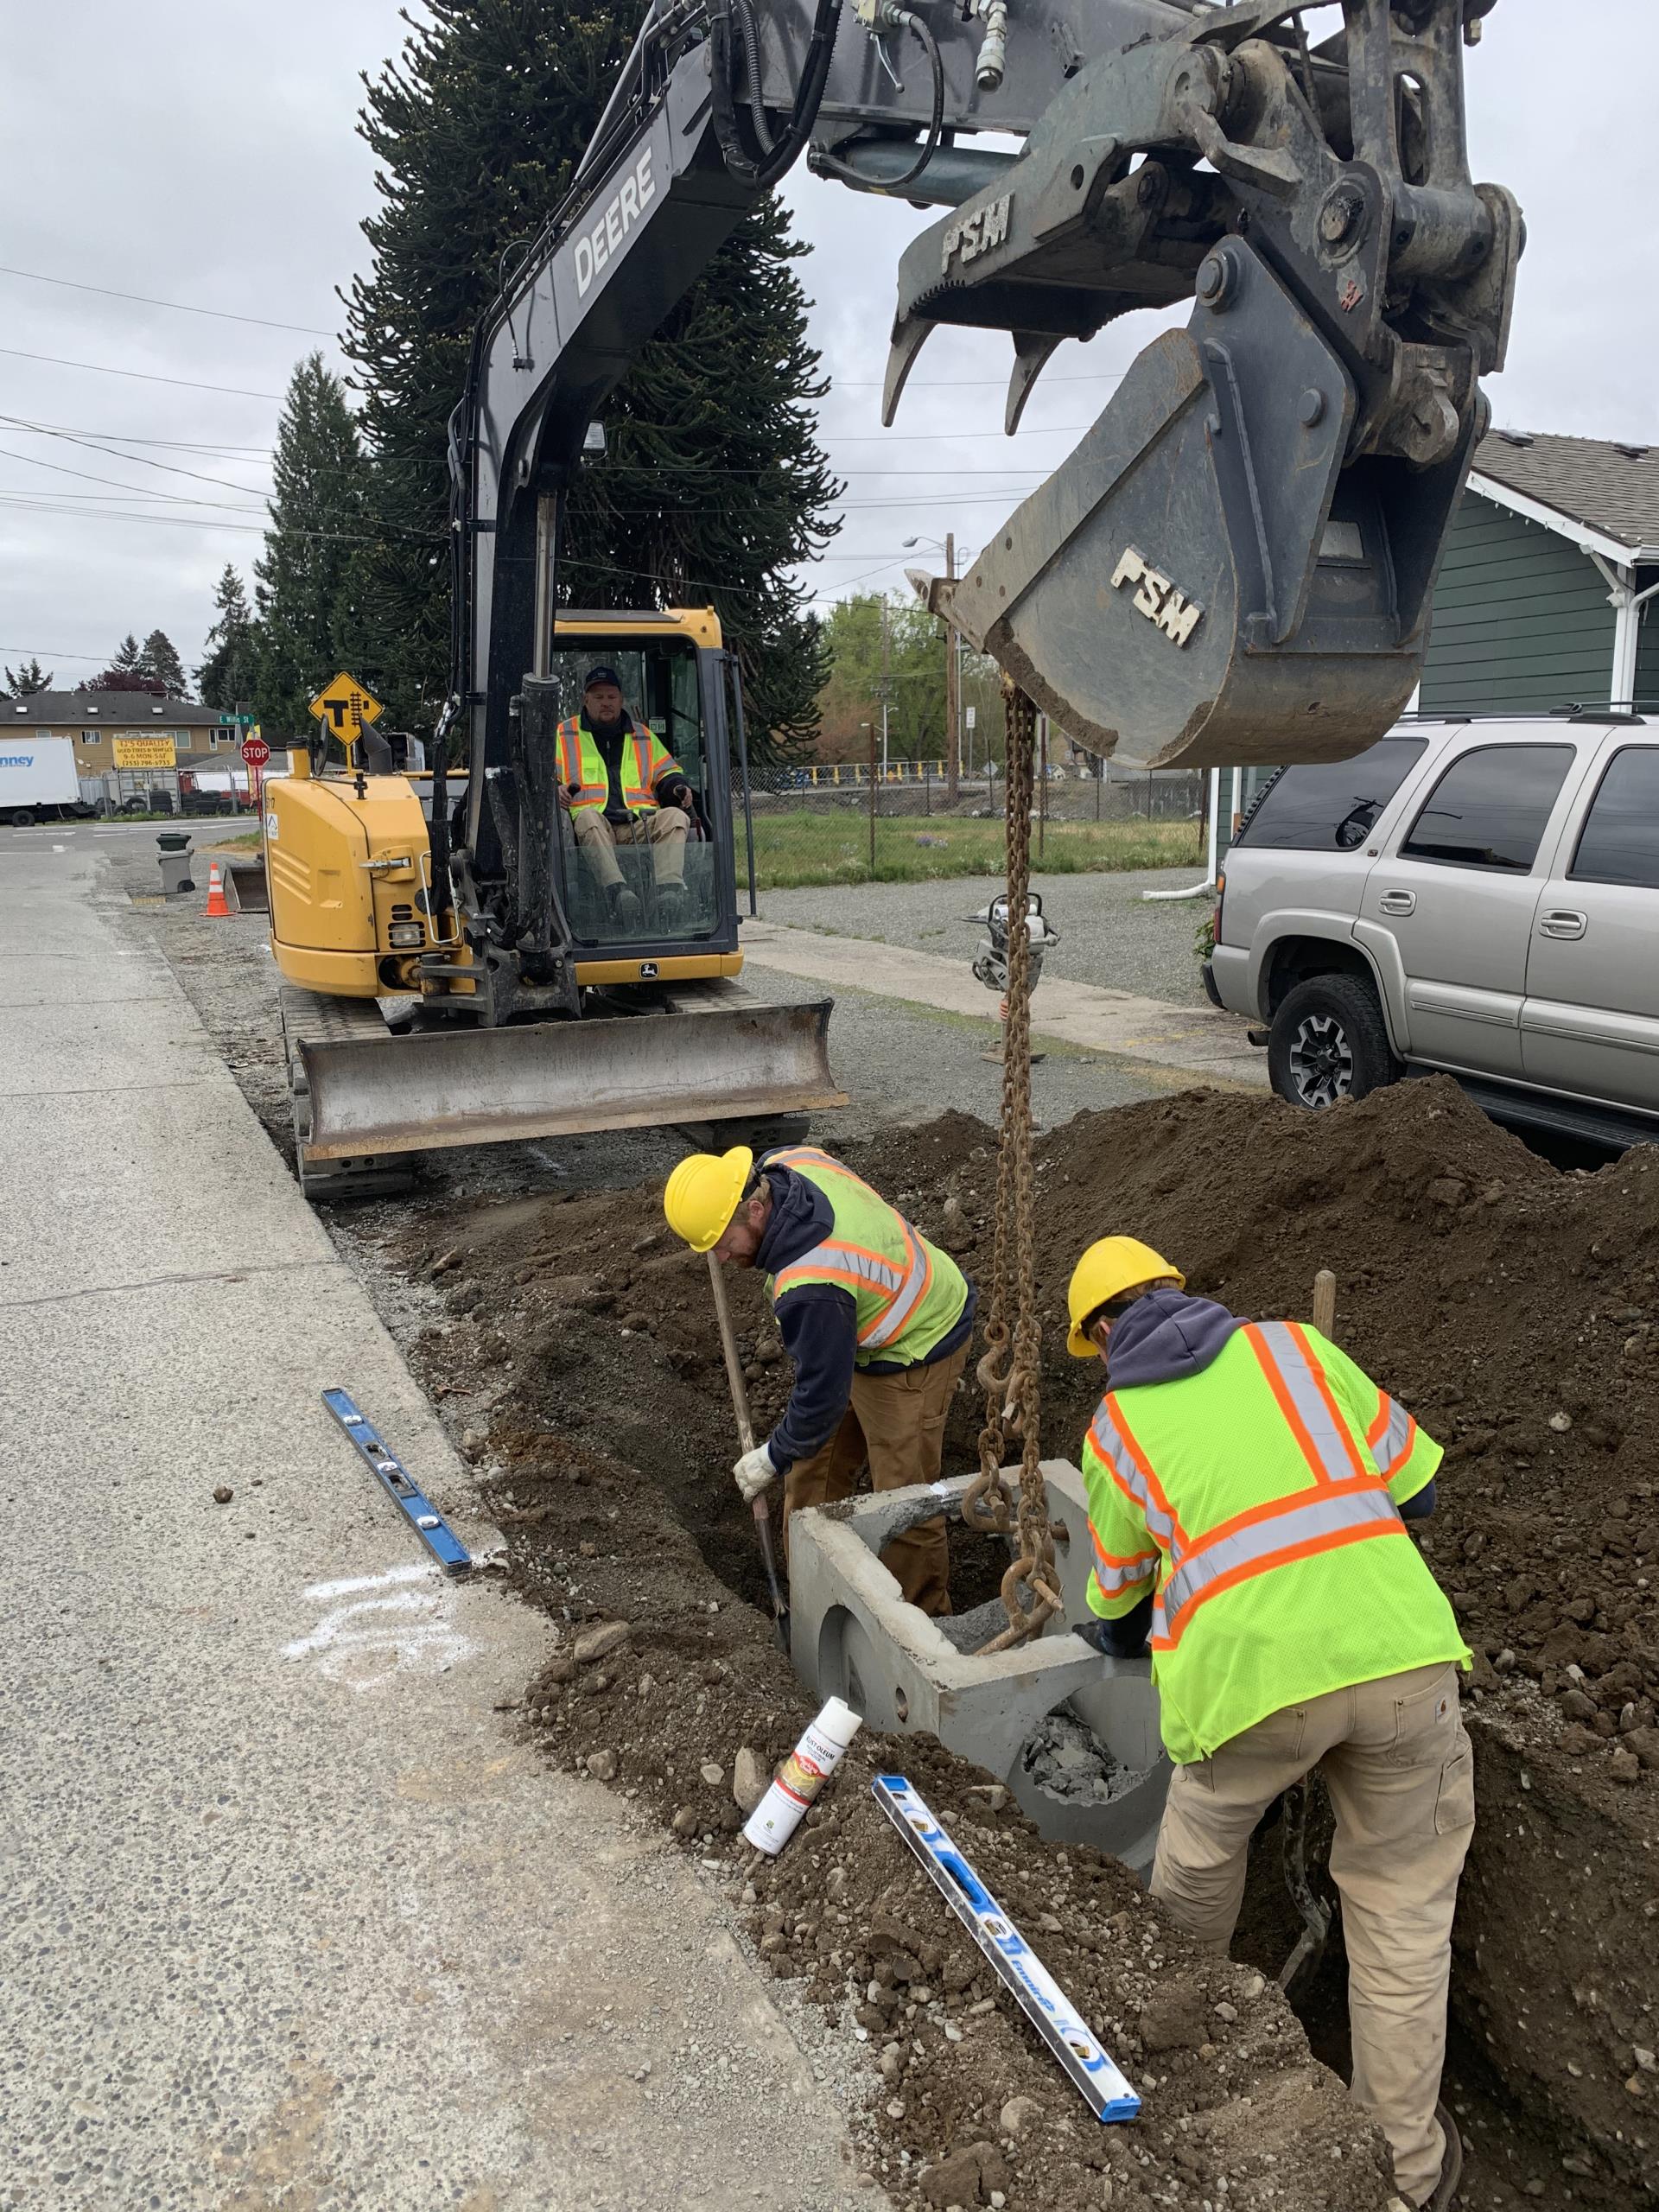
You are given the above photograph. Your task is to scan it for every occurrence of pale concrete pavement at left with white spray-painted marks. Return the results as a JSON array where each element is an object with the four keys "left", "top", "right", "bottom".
[{"left": 0, "top": 841, "right": 872, "bottom": 2212}]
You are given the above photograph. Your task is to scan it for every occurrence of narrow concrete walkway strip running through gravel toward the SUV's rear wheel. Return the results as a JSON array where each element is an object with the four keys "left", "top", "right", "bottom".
[{"left": 743, "top": 918, "right": 1268, "bottom": 1090}]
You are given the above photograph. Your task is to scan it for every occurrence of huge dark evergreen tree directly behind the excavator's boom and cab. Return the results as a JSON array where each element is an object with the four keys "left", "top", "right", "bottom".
[{"left": 347, "top": 0, "right": 838, "bottom": 754}]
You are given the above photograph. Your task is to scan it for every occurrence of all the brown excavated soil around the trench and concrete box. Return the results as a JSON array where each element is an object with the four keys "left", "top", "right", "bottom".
[{"left": 358, "top": 1082, "right": 1659, "bottom": 2212}]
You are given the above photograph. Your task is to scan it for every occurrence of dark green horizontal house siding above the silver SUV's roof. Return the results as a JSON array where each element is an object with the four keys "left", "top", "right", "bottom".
[{"left": 1421, "top": 491, "right": 1618, "bottom": 715}]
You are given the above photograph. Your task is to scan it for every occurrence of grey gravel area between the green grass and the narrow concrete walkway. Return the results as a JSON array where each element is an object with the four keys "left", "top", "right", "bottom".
[{"left": 761, "top": 861, "right": 1210, "bottom": 1007}]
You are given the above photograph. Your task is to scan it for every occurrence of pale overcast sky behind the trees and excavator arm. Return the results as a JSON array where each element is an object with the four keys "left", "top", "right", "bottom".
[{"left": 0, "top": 0, "right": 1659, "bottom": 683}]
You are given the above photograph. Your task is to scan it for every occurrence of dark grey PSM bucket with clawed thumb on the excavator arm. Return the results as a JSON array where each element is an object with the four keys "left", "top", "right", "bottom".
[{"left": 889, "top": 0, "right": 1522, "bottom": 767}]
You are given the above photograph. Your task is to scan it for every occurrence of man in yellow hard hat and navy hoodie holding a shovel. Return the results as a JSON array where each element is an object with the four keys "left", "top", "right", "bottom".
[{"left": 664, "top": 1144, "right": 978, "bottom": 1612}]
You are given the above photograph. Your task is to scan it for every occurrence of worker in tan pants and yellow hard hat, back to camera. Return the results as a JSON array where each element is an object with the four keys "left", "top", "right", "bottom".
[{"left": 1068, "top": 1236, "right": 1476, "bottom": 2208}]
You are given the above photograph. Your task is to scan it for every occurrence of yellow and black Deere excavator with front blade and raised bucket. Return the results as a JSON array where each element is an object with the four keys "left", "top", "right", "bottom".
[{"left": 268, "top": 0, "right": 1524, "bottom": 1190}]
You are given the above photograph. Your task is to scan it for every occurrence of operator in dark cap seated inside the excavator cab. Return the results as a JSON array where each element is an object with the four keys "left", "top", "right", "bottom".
[{"left": 557, "top": 668, "right": 692, "bottom": 929}]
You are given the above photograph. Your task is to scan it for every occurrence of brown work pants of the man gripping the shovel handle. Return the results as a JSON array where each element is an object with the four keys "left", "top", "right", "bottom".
[{"left": 783, "top": 1344, "right": 969, "bottom": 1612}]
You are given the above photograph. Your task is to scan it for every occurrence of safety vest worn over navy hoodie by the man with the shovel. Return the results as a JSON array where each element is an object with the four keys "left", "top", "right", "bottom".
[{"left": 763, "top": 1144, "right": 967, "bottom": 1367}]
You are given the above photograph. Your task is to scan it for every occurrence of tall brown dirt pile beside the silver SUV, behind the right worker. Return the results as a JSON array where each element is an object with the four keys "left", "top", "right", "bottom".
[{"left": 869, "top": 1082, "right": 1659, "bottom": 1781}]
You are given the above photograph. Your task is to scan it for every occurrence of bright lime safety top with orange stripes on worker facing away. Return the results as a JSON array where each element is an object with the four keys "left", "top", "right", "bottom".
[{"left": 1084, "top": 1320, "right": 1469, "bottom": 1763}]
